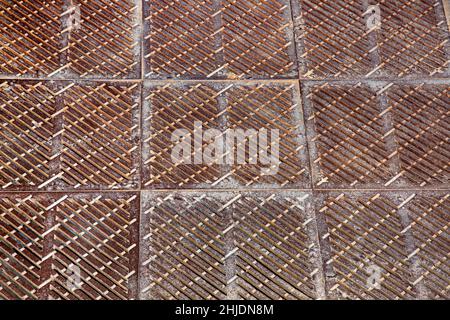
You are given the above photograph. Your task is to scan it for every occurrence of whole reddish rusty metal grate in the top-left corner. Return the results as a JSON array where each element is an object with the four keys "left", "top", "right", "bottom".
[{"left": 0, "top": 0, "right": 140, "bottom": 78}]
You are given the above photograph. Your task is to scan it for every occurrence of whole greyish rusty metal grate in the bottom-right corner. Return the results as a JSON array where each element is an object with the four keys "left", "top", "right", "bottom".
[{"left": 316, "top": 192, "right": 449, "bottom": 299}]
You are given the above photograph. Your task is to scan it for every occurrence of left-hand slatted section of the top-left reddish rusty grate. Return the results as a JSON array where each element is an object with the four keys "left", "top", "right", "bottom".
[{"left": 0, "top": 0, "right": 63, "bottom": 77}]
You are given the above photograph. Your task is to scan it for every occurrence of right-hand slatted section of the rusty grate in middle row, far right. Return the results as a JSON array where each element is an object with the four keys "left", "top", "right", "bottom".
[{"left": 388, "top": 84, "right": 450, "bottom": 186}]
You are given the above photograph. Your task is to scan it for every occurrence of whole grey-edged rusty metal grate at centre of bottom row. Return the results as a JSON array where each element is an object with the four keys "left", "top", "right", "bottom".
[{"left": 141, "top": 193, "right": 318, "bottom": 300}]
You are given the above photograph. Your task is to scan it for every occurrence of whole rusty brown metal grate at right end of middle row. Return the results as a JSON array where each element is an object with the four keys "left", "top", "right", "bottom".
[{"left": 305, "top": 83, "right": 450, "bottom": 188}]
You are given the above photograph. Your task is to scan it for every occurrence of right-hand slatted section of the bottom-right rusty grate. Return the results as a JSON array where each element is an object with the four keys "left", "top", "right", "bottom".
[{"left": 408, "top": 194, "right": 450, "bottom": 300}]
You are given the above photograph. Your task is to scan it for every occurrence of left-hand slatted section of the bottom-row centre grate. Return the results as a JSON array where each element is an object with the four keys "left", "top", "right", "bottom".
[{"left": 141, "top": 195, "right": 229, "bottom": 300}]
